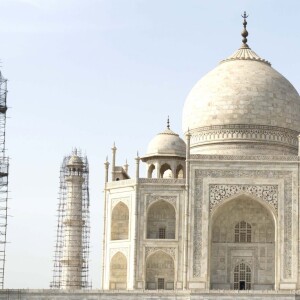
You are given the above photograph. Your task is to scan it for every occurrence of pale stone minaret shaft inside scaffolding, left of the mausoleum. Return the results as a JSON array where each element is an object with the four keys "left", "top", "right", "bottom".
[{"left": 61, "top": 150, "right": 84, "bottom": 289}]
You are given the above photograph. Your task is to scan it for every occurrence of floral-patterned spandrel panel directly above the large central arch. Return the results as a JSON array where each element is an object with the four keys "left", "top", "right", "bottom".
[{"left": 209, "top": 184, "right": 278, "bottom": 211}]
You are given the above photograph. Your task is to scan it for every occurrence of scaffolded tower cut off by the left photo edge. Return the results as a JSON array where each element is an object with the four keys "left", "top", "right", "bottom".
[{"left": 0, "top": 71, "right": 8, "bottom": 289}]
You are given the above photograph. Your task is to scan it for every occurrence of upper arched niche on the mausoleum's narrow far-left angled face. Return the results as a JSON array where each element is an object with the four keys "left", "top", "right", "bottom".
[{"left": 111, "top": 202, "right": 129, "bottom": 240}]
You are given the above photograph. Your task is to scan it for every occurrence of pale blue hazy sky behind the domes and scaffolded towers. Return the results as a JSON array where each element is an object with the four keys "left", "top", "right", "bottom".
[{"left": 0, "top": 0, "right": 300, "bottom": 288}]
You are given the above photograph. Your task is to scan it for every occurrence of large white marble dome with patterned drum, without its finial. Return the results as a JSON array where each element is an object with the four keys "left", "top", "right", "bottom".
[{"left": 183, "top": 45, "right": 300, "bottom": 154}]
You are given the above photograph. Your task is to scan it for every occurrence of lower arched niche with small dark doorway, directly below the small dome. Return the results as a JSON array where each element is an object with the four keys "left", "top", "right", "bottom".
[{"left": 146, "top": 251, "right": 175, "bottom": 290}]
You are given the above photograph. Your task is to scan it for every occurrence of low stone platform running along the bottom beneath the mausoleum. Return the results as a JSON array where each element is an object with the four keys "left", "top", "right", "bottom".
[{"left": 0, "top": 289, "right": 300, "bottom": 300}]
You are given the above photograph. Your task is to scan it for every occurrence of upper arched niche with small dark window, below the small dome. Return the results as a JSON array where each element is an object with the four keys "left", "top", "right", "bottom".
[{"left": 147, "top": 200, "right": 176, "bottom": 239}]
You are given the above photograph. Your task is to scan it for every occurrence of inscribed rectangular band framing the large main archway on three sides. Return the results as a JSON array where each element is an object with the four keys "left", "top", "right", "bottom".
[{"left": 193, "top": 169, "right": 296, "bottom": 279}]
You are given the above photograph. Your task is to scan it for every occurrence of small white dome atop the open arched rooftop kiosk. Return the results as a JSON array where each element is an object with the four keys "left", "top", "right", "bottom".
[{"left": 145, "top": 128, "right": 186, "bottom": 157}]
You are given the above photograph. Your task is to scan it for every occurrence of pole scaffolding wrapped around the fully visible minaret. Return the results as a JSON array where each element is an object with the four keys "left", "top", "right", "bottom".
[{"left": 50, "top": 151, "right": 91, "bottom": 289}]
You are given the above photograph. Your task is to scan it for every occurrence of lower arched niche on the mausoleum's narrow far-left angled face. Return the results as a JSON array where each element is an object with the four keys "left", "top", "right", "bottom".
[{"left": 109, "top": 252, "right": 127, "bottom": 290}]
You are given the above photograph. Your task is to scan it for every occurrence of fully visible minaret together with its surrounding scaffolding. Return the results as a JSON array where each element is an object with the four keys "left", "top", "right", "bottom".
[{"left": 50, "top": 150, "right": 90, "bottom": 289}]
